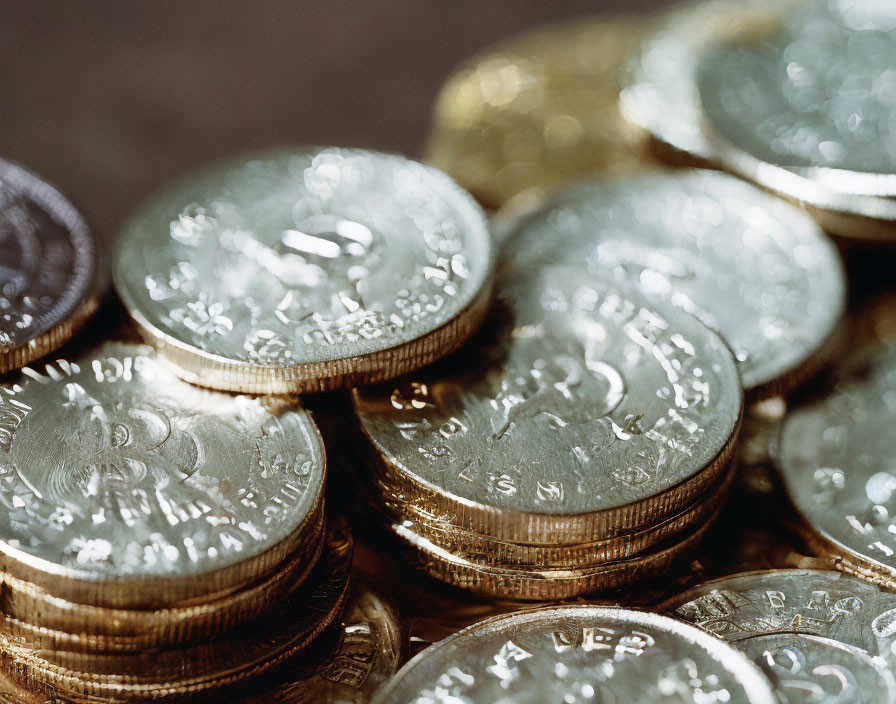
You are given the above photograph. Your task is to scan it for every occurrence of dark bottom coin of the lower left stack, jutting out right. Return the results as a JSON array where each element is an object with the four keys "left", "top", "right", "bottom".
[{"left": 0, "top": 526, "right": 352, "bottom": 702}]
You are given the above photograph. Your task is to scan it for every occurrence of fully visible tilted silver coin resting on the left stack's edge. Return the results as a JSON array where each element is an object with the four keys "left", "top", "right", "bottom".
[{"left": 113, "top": 148, "right": 492, "bottom": 393}]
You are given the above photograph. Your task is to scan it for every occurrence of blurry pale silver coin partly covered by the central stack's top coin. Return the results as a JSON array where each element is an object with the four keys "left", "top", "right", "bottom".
[{"left": 506, "top": 171, "right": 846, "bottom": 400}]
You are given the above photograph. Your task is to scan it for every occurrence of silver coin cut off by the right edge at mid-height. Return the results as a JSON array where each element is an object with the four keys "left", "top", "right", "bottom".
[{"left": 775, "top": 345, "right": 896, "bottom": 585}]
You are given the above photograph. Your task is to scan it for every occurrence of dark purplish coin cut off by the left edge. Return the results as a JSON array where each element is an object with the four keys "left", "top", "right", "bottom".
[{"left": 0, "top": 159, "right": 100, "bottom": 373}]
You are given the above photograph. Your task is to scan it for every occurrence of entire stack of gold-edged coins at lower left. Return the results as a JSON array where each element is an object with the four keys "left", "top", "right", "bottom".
[{"left": 0, "top": 342, "right": 351, "bottom": 701}]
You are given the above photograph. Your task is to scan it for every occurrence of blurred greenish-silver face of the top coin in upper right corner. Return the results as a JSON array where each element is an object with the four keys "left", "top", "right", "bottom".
[{"left": 697, "top": 0, "right": 896, "bottom": 195}]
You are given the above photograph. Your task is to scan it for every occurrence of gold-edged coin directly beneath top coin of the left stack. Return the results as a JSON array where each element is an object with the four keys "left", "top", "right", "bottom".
[{"left": 0, "top": 508, "right": 324, "bottom": 653}]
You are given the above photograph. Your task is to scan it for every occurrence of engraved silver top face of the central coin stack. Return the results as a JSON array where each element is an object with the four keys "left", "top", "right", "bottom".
[{"left": 355, "top": 263, "right": 742, "bottom": 524}]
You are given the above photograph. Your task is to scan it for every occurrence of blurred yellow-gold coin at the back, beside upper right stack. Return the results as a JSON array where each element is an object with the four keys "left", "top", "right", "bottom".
[{"left": 426, "top": 18, "right": 644, "bottom": 206}]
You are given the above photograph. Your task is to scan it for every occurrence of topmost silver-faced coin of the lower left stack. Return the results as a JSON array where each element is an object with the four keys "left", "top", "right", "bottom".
[{"left": 0, "top": 343, "right": 325, "bottom": 609}]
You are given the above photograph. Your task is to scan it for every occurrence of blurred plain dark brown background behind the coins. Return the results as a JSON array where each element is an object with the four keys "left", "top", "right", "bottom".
[{"left": 0, "top": 0, "right": 669, "bottom": 237}]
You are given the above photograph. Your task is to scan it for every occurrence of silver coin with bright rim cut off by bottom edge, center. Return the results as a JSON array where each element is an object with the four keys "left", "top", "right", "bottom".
[{"left": 374, "top": 606, "right": 775, "bottom": 704}]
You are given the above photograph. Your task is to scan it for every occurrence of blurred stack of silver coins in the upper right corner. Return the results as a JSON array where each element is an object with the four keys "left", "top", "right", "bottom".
[{"left": 622, "top": 0, "right": 896, "bottom": 240}]
